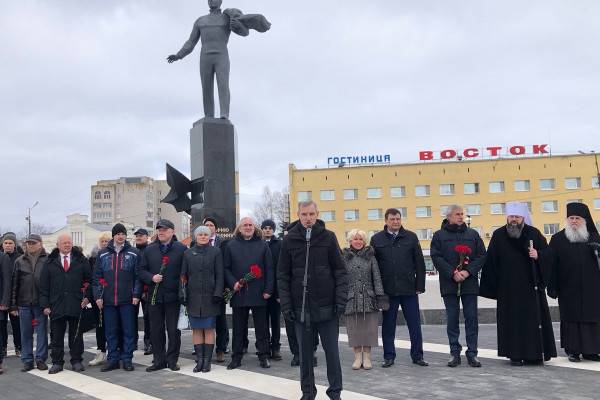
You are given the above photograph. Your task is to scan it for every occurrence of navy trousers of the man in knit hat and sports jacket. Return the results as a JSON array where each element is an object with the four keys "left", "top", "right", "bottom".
[{"left": 103, "top": 304, "right": 135, "bottom": 364}]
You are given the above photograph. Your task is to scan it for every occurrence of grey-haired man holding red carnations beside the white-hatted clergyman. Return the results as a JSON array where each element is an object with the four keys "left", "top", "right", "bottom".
[{"left": 431, "top": 205, "right": 485, "bottom": 367}]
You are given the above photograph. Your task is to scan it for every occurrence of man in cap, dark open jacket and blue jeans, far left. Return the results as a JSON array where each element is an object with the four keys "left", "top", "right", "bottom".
[{"left": 11, "top": 233, "right": 48, "bottom": 372}]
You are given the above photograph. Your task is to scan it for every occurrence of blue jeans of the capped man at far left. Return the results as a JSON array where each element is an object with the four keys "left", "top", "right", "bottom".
[{"left": 19, "top": 306, "right": 48, "bottom": 363}]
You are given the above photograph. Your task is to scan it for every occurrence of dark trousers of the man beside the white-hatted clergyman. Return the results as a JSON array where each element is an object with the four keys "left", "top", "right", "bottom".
[{"left": 443, "top": 294, "right": 479, "bottom": 358}]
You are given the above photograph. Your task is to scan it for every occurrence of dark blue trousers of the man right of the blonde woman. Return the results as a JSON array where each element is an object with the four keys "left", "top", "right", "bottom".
[{"left": 381, "top": 294, "right": 423, "bottom": 361}]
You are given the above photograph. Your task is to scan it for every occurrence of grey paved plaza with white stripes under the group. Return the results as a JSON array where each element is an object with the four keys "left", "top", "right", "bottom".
[{"left": 0, "top": 324, "right": 600, "bottom": 400}]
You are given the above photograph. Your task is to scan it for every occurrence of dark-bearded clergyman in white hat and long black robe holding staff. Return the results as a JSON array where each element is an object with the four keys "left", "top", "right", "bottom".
[{"left": 479, "top": 203, "right": 556, "bottom": 366}]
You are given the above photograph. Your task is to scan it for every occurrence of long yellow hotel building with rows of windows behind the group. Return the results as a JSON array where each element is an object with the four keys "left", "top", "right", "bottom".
[{"left": 289, "top": 154, "right": 600, "bottom": 268}]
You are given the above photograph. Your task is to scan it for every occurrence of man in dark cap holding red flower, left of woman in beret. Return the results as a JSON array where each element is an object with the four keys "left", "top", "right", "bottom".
[{"left": 138, "top": 219, "right": 187, "bottom": 372}]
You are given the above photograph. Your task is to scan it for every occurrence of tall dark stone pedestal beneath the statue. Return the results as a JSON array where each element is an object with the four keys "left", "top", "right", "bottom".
[{"left": 190, "top": 118, "right": 239, "bottom": 233}]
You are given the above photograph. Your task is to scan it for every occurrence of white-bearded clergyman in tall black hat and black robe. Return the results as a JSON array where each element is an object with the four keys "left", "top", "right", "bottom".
[{"left": 548, "top": 203, "right": 600, "bottom": 362}]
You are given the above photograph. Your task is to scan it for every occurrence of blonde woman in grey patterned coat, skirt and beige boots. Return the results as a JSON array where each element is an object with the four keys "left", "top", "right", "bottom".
[{"left": 343, "top": 229, "right": 386, "bottom": 369}]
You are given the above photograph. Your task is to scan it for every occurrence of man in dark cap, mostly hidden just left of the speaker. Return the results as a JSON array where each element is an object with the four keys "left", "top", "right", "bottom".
[{"left": 260, "top": 219, "right": 281, "bottom": 361}]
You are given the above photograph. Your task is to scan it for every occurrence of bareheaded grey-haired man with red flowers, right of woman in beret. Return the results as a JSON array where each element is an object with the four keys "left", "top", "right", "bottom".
[{"left": 223, "top": 218, "right": 274, "bottom": 369}]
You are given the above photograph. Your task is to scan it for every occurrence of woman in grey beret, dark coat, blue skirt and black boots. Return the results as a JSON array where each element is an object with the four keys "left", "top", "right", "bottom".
[{"left": 181, "top": 226, "right": 223, "bottom": 372}]
